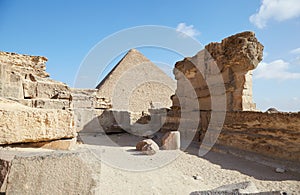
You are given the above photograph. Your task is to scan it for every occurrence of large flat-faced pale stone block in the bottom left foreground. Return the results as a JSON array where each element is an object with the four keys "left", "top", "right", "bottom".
[{"left": 0, "top": 150, "right": 101, "bottom": 194}]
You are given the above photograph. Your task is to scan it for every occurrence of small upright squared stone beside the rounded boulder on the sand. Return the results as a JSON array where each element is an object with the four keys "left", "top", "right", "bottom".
[{"left": 161, "top": 131, "right": 180, "bottom": 150}]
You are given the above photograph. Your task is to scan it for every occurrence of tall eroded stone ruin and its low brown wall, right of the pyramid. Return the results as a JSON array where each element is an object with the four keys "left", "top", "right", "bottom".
[{"left": 162, "top": 32, "right": 300, "bottom": 162}]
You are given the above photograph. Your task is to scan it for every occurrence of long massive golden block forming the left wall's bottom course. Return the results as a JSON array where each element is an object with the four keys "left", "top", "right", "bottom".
[{"left": 0, "top": 98, "right": 76, "bottom": 144}]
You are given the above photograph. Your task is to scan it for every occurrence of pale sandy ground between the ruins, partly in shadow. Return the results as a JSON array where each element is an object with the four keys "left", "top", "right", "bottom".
[{"left": 80, "top": 134, "right": 300, "bottom": 194}]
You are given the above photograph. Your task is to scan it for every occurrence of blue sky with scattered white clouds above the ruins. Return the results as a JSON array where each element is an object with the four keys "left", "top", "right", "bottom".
[{"left": 0, "top": 0, "right": 300, "bottom": 111}]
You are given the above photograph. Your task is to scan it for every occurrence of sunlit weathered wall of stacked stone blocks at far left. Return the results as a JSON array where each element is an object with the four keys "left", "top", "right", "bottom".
[{"left": 0, "top": 52, "right": 76, "bottom": 145}]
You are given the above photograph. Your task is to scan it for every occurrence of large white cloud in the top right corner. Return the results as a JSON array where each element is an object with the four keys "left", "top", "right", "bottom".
[{"left": 249, "top": 0, "right": 300, "bottom": 28}]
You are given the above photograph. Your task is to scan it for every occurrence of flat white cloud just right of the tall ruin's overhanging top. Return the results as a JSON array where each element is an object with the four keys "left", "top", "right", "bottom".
[{"left": 254, "top": 60, "right": 300, "bottom": 80}]
